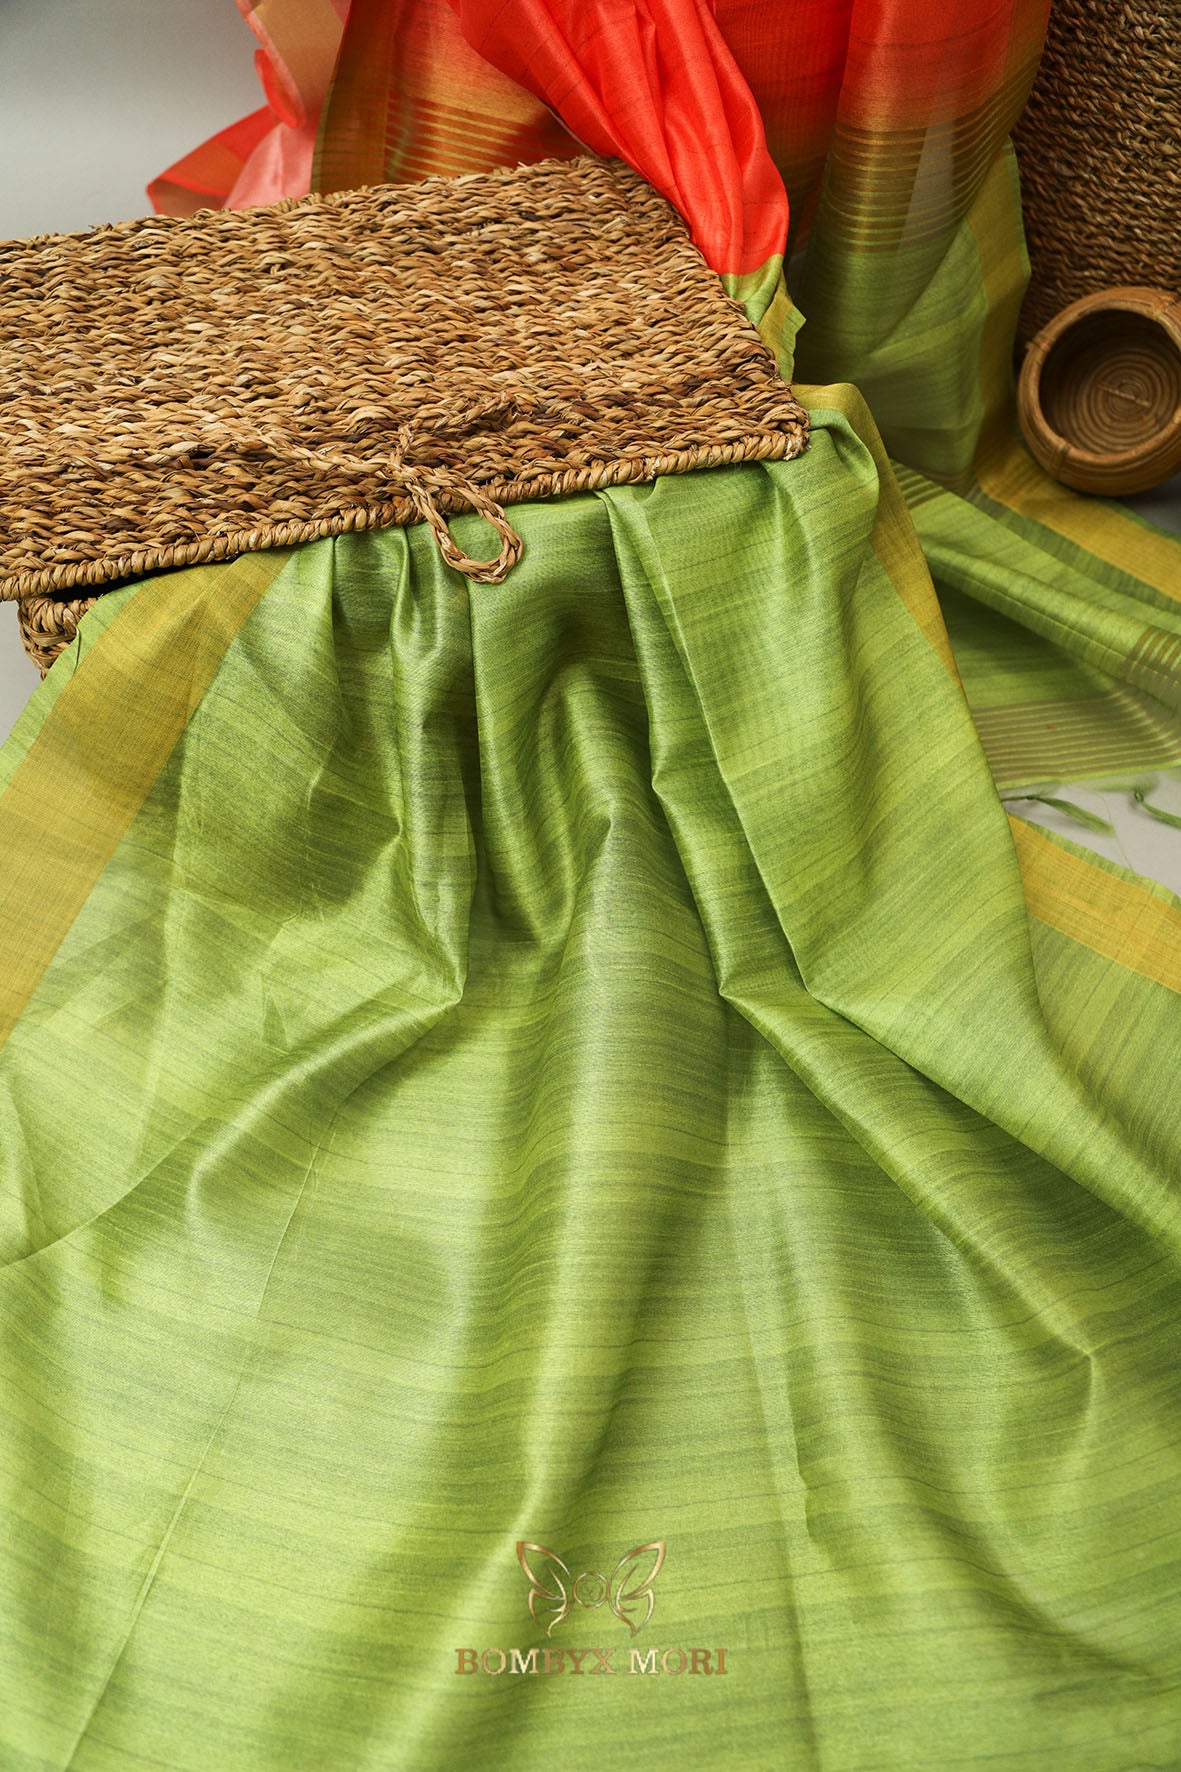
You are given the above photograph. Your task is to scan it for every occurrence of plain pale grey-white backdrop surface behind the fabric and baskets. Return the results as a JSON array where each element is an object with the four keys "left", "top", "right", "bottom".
[{"left": 0, "top": 0, "right": 1181, "bottom": 891}]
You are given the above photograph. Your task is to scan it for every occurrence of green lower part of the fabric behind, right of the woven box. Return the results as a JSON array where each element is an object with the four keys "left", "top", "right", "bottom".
[{"left": 780, "top": 150, "right": 1181, "bottom": 804}]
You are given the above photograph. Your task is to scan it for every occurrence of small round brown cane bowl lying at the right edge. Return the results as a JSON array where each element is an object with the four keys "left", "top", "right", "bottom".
[{"left": 1018, "top": 289, "right": 1181, "bottom": 496}]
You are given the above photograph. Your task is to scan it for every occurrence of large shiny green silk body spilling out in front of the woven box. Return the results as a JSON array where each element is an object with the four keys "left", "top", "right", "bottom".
[{"left": 0, "top": 408, "right": 1181, "bottom": 1772}]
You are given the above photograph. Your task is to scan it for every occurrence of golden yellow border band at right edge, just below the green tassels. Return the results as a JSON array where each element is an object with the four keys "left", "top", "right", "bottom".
[{"left": 1009, "top": 813, "right": 1181, "bottom": 991}]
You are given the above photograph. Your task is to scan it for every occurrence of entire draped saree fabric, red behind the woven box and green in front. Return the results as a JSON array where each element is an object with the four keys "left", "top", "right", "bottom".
[{"left": 0, "top": 0, "right": 1181, "bottom": 1772}]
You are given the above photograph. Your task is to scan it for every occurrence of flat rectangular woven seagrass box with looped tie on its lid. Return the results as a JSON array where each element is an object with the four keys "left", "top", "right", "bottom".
[{"left": 0, "top": 158, "right": 807, "bottom": 668}]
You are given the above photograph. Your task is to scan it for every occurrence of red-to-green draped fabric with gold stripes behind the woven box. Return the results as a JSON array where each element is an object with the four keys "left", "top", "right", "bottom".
[{"left": 153, "top": 0, "right": 1181, "bottom": 790}]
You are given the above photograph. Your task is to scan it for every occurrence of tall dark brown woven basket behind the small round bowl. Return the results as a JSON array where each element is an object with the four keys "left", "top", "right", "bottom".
[{"left": 1013, "top": 0, "right": 1181, "bottom": 344}]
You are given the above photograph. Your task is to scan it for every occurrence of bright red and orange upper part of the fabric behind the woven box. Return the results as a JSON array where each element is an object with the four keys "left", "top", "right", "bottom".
[{"left": 151, "top": 0, "right": 1048, "bottom": 283}]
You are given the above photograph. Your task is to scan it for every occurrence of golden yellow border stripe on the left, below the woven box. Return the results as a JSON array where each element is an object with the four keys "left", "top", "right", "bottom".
[{"left": 0, "top": 549, "right": 291, "bottom": 1045}]
